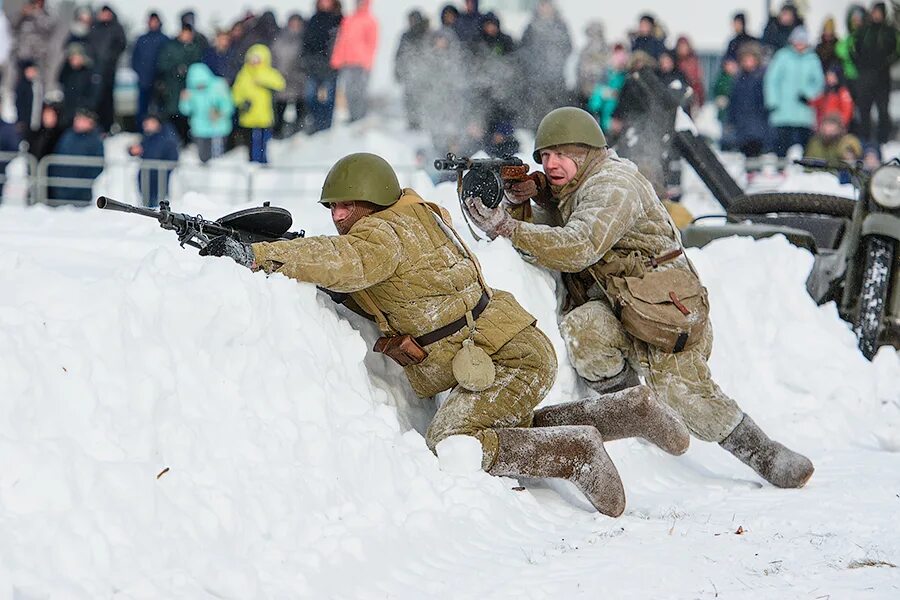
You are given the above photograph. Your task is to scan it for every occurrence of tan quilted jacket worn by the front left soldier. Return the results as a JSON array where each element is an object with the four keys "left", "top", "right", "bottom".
[{"left": 253, "top": 189, "right": 535, "bottom": 397}]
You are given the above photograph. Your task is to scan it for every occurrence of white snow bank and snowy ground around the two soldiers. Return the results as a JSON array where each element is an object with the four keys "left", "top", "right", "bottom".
[{"left": 0, "top": 119, "right": 900, "bottom": 600}]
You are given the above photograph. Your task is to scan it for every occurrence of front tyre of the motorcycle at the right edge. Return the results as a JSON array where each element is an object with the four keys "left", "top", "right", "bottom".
[{"left": 854, "top": 236, "right": 895, "bottom": 360}]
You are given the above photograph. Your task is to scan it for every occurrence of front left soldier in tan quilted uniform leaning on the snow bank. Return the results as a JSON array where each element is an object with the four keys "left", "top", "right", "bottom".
[{"left": 205, "top": 153, "right": 689, "bottom": 516}]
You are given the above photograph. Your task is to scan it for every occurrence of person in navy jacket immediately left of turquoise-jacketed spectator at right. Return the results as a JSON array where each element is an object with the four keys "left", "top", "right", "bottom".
[{"left": 725, "top": 42, "right": 771, "bottom": 157}]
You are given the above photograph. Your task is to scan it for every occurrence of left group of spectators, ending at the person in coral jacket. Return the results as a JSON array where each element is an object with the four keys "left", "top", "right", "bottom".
[{"left": 0, "top": 0, "right": 378, "bottom": 205}]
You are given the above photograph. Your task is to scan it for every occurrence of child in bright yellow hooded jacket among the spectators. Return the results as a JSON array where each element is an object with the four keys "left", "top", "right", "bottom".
[{"left": 231, "top": 44, "right": 285, "bottom": 164}]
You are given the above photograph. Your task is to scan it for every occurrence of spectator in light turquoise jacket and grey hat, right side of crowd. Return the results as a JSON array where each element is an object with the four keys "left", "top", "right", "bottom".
[{"left": 764, "top": 27, "right": 825, "bottom": 157}]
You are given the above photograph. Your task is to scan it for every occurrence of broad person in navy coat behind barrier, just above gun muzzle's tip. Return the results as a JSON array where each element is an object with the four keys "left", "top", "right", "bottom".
[{"left": 49, "top": 109, "right": 103, "bottom": 206}]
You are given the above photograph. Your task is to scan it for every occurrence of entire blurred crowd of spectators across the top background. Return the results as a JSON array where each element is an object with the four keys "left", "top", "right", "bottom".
[{"left": 0, "top": 0, "right": 900, "bottom": 203}]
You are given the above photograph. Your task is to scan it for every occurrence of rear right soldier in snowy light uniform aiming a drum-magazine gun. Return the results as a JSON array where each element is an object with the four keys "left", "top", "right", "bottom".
[{"left": 466, "top": 107, "right": 813, "bottom": 487}]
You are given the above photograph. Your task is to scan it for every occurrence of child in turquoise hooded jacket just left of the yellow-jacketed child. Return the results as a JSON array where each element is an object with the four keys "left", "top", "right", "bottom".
[{"left": 178, "top": 63, "right": 234, "bottom": 164}]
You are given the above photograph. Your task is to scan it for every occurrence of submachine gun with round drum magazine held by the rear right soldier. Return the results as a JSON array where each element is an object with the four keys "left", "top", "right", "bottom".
[{"left": 434, "top": 153, "right": 535, "bottom": 208}]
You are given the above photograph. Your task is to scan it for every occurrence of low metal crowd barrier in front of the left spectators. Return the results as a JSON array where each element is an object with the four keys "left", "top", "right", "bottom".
[{"left": 7, "top": 152, "right": 427, "bottom": 206}]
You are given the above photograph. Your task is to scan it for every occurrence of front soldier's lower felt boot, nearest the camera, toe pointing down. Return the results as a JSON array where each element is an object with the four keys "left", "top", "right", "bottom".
[{"left": 488, "top": 426, "right": 625, "bottom": 517}]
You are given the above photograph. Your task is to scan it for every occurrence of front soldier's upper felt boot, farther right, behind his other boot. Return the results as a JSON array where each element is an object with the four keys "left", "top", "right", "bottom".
[{"left": 533, "top": 385, "right": 691, "bottom": 456}]
